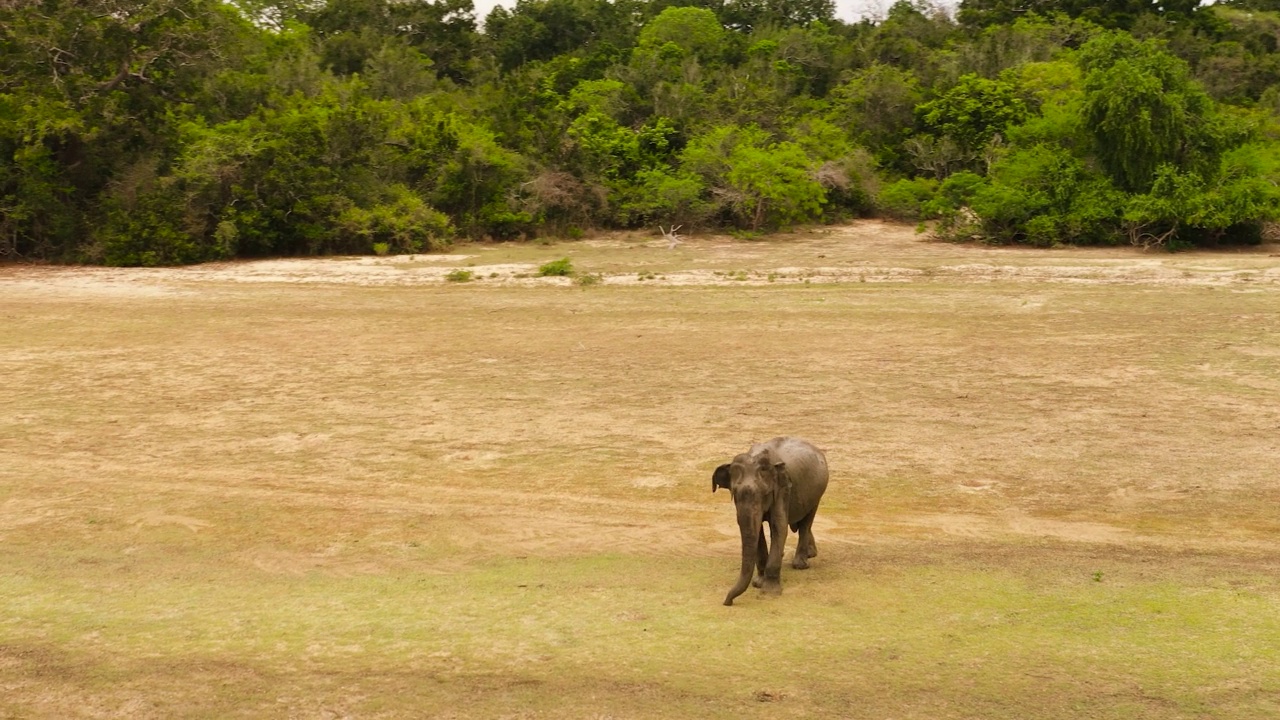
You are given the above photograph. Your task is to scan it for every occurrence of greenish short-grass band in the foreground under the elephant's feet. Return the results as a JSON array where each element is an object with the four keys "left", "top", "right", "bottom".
[{"left": 0, "top": 555, "right": 1280, "bottom": 719}]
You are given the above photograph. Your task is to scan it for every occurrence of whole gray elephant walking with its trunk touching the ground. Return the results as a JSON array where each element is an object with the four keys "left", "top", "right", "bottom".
[{"left": 712, "top": 437, "right": 827, "bottom": 605}]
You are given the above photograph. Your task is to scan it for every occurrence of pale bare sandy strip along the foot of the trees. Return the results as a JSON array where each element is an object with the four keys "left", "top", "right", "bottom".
[{"left": 10, "top": 220, "right": 1280, "bottom": 296}]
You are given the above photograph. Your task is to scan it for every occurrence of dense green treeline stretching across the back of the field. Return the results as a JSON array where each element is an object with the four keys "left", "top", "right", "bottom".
[{"left": 0, "top": 0, "right": 1280, "bottom": 265}]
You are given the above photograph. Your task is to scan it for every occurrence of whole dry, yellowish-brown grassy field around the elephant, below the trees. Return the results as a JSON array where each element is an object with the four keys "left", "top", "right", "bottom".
[{"left": 0, "top": 223, "right": 1280, "bottom": 720}]
